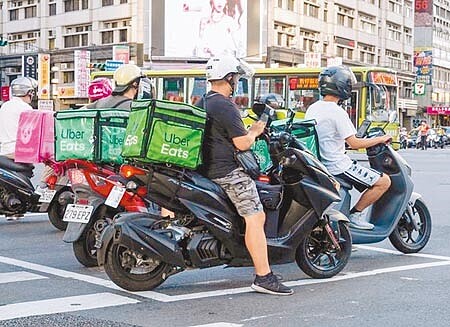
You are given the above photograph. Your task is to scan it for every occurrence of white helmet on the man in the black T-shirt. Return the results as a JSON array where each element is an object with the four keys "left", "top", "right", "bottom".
[{"left": 206, "top": 55, "right": 255, "bottom": 81}]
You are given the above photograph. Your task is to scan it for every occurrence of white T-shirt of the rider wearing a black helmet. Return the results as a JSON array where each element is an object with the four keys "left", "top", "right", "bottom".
[{"left": 305, "top": 100, "right": 356, "bottom": 175}]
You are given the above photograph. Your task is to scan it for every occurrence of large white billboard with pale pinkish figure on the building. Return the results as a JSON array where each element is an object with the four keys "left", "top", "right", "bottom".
[{"left": 164, "top": 0, "right": 247, "bottom": 58}]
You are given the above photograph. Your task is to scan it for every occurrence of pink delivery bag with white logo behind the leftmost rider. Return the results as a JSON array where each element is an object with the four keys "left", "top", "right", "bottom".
[{"left": 14, "top": 110, "right": 55, "bottom": 163}]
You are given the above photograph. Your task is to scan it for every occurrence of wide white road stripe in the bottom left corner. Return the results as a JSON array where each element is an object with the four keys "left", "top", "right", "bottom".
[{"left": 0, "top": 293, "right": 139, "bottom": 321}]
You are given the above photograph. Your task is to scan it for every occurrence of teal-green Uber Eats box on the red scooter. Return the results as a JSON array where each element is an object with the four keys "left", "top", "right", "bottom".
[{"left": 55, "top": 109, "right": 129, "bottom": 164}]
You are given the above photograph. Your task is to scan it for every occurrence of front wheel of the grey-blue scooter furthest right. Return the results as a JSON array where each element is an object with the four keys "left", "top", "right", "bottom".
[{"left": 389, "top": 199, "right": 431, "bottom": 253}]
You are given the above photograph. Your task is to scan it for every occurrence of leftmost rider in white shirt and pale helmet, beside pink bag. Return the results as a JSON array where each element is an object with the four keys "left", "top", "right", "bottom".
[{"left": 0, "top": 77, "right": 38, "bottom": 159}]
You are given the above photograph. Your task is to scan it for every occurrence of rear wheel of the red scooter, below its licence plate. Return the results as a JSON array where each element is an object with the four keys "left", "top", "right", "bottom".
[{"left": 72, "top": 216, "right": 108, "bottom": 267}]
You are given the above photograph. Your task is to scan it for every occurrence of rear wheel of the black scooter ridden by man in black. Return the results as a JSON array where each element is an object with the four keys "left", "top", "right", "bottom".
[{"left": 105, "top": 244, "right": 171, "bottom": 292}]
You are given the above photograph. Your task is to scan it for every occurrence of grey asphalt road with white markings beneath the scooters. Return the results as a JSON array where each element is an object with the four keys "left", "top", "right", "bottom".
[{"left": 0, "top": 149, "right": 450, "bottom": 327}]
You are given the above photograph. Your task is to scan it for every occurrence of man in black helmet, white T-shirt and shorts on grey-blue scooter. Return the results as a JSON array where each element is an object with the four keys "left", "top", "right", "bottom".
[{"left": 305, "top": 66, "right": 391, "bottom": 229}]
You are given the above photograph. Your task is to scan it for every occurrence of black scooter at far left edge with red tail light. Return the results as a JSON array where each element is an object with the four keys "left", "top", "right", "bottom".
[{"left": 0, "top": 156, "right": 73, "bottom": 230}]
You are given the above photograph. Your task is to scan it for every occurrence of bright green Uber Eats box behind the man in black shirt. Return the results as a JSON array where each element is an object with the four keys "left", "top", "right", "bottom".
[{"left": 122, "top": 100, "right": 206, "bottom": 169}]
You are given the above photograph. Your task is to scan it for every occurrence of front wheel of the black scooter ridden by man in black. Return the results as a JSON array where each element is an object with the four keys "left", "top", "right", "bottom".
[{"left": 295, "top": 222, "right": 352, "bottom": 278}]
